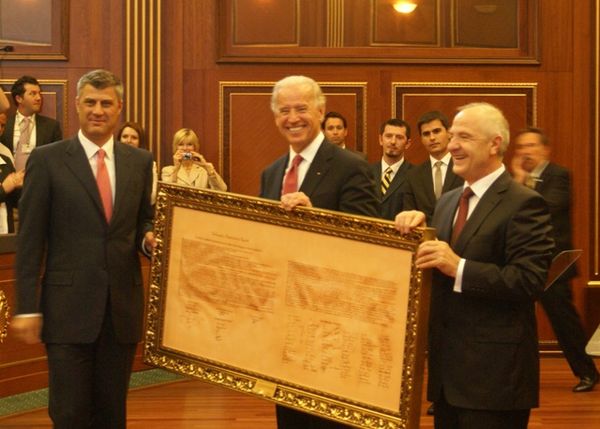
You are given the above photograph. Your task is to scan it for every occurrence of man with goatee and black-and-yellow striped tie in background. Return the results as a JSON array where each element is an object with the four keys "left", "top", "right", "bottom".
[{"left": 371, "top": 118, "right": 413, "bottom": 220}]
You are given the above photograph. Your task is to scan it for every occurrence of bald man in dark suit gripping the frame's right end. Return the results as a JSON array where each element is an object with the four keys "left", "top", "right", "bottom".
[{"left": 396, "top": 103, "right": 554, "bottom": 429}]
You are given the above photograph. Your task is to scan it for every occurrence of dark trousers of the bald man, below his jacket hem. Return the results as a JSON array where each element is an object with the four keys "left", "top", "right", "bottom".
[{"left": 433, "top": 394, "right": 530, "bottom": 429}]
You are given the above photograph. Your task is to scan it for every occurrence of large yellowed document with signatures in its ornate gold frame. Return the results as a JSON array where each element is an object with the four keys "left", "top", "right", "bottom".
[{"left": 144, "top": 183, "right": 433, "bottom": 429}]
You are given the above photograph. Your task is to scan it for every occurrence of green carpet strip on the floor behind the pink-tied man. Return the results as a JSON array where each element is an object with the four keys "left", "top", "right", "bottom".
[{"left": 0, "top": 369, "right": 185, "bottom": 417}]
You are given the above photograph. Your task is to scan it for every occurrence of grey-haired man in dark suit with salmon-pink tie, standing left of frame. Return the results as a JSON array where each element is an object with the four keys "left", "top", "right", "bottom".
[{"left": 12, "top": 70, "right": 155, "bottom": 429}]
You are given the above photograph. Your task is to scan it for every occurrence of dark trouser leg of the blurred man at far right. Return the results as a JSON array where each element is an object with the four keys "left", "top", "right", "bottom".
[{"left": 541, "top": 279, "right": 597, "bottom": 377}]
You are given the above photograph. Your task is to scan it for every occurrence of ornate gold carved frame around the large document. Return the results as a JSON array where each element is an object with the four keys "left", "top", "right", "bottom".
[{"left": 144, "top": 183, "right": 434, "bottom": 429}]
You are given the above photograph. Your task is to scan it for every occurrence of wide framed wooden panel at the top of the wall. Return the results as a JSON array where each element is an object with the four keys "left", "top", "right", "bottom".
[{"left": 216, "top": 0, "right": 541, "bottom": 64}]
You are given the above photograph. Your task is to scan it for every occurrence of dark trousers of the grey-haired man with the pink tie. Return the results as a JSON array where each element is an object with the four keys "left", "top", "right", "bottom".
[{"left": 46, "top": 311, "right": 136, "bottom": 429}]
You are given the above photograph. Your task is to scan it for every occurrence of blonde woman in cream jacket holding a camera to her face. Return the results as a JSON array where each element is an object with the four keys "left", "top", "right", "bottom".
[{"left": 161, "top": 128, "right": 227, "bottom": 191}]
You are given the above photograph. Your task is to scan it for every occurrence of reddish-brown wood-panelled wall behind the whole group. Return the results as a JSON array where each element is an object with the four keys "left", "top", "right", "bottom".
[{"left": 0, "top": 0, "right": 600, "bottom": 396}]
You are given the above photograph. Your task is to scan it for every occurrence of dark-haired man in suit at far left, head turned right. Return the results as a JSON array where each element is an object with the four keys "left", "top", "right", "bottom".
[{"left": 0, "top": 76, "right": 62, "bottom": 170}]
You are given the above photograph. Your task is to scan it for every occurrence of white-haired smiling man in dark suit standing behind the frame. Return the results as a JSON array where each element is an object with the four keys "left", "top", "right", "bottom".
[{"left": 260, "top": 76, "right": 378, "bottom": 429}]
